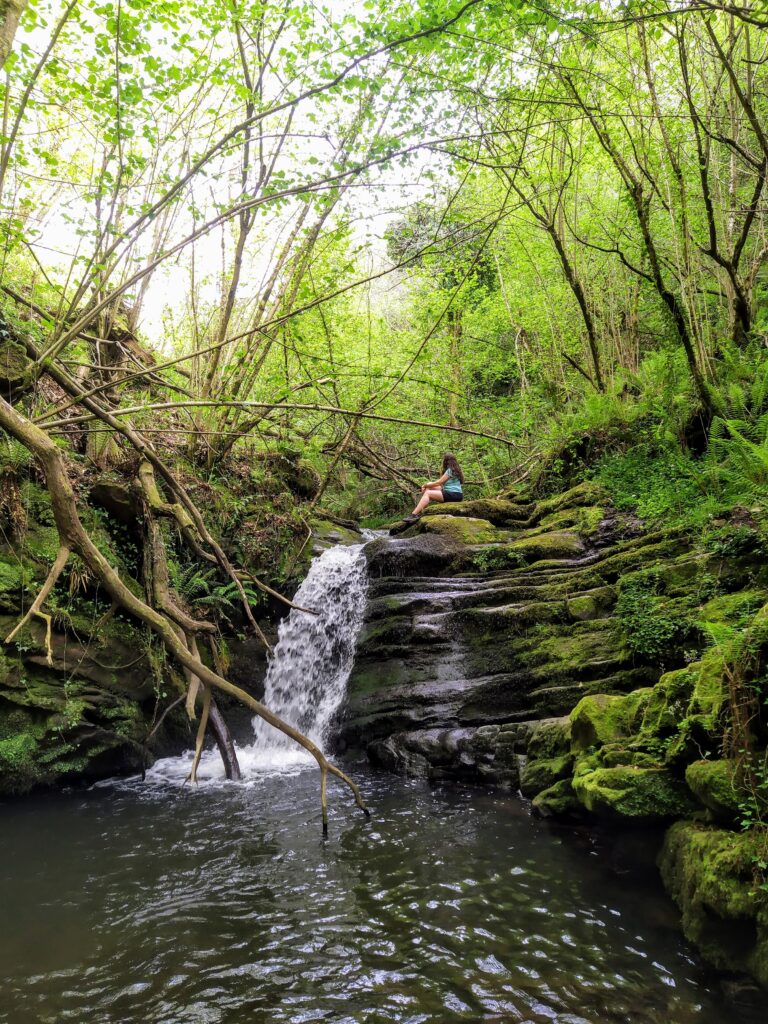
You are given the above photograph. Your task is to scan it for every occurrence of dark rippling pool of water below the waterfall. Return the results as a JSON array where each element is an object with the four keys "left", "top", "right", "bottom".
[{"left": 0, "top": 768, "right": 764, "bottom": 1024}]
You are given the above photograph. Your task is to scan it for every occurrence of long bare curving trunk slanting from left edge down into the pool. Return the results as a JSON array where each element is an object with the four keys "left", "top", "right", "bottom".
[{"left": 0, "top": 397, "right": 369, "bottom": 827}]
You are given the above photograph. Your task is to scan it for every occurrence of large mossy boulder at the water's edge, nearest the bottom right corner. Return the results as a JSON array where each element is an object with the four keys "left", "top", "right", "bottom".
[{"left": 658, "top": 821, "right": 768, "bottom": 988}]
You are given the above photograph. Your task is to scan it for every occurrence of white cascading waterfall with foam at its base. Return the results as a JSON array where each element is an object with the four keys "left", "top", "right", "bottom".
[{"left": 133, "top": 534, "right": 373, "bottom": 785}]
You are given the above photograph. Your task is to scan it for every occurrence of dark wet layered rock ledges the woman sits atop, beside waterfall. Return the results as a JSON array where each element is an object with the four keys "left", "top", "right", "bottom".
[{"left": 341, "top": 486, "right": 671, "bottom": 774}]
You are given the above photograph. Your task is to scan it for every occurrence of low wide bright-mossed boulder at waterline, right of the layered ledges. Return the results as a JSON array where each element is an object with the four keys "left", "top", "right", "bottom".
[{"left": 571, "top": 759, "right": 694, "bottom": 822}]
